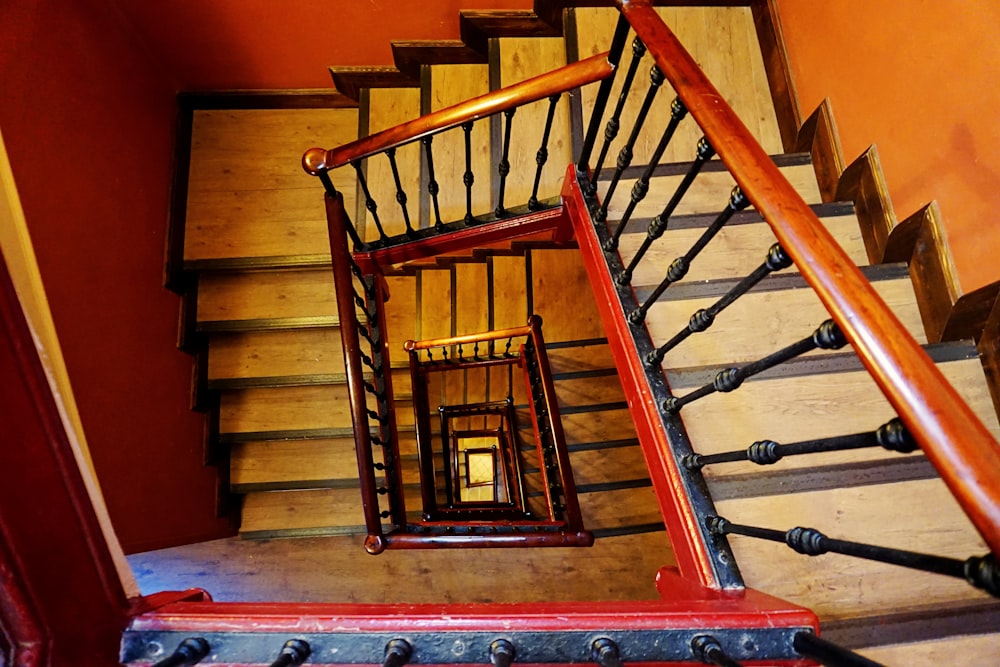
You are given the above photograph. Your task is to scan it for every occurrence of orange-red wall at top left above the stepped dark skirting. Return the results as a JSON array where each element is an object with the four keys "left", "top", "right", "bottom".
[{"left": 115, "top": 0, "right": 532, "bottom": 90}]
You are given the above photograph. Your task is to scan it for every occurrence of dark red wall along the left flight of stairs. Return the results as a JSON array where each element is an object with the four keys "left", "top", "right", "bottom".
[{"left": 0, "top": 0, "right": 232, "bottom": 552}]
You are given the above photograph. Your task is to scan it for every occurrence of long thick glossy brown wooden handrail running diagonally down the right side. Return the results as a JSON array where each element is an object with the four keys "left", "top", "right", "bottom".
[{"left": 618, "top": 0, "right": 1000, "bottom": 553}]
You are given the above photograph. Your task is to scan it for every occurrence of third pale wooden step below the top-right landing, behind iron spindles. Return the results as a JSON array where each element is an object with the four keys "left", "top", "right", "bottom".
[{"left": 646, "top": 265, "right": 926, "bottom": 368}]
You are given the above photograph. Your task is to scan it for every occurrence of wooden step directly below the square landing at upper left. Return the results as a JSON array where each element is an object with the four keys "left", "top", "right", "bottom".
[{"left": 198, "top": 269, "right": 339, "bottom": 330}]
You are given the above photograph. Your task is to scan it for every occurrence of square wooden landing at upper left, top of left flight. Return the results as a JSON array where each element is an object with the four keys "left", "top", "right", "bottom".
[{"left": 184, "top": 109, "right": 358, "bottom": 261}]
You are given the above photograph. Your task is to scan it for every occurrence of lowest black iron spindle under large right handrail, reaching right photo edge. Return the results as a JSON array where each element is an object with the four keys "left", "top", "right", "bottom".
[{"left": 706, "top": 516, "right": 1000, "bottom": 597}]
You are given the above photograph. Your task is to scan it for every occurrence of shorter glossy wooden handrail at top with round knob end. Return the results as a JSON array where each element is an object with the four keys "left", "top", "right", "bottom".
[{"left": 302, "top": 53, "right": 615, "bottom": 176}]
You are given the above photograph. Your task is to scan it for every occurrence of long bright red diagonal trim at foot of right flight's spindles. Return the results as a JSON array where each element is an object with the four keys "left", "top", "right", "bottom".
[{"left": 562, "top": 165, "right": 719, "bottom": 588}]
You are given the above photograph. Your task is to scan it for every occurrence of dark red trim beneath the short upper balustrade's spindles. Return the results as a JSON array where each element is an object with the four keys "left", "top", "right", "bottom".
[{"left": 354, "top": 207, "right": 570, "bottom": 273}]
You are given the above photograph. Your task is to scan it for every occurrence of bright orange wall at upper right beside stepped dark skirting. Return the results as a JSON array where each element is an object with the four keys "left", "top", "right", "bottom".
[{"left": 777, "top": 0, "right": 1000, "bottom": 291}]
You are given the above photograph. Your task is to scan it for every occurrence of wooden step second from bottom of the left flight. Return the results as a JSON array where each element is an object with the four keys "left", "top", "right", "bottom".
[{"left": 229, "top": 438, "right": 358, "bottom": 493}]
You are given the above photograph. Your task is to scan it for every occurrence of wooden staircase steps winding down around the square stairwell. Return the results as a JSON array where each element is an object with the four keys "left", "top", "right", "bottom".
[{"left": 164, "top": 2, "right": 1000, "bottom": 664}]
